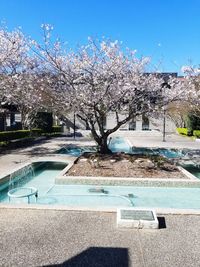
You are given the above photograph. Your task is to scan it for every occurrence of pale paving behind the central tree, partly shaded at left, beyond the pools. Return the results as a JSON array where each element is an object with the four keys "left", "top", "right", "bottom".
[{"left": 0, "top": 131, "right": 200, "bottom": 176}]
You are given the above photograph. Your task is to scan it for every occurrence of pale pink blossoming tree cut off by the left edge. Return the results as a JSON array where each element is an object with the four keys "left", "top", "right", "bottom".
[{"left": 0, "top": 28, "right": 57, "bottom": 129}]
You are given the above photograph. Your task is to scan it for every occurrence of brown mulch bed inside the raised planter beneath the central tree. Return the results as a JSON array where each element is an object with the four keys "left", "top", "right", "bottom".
[{"left": 66, "top": 153, "right": 189, "bottom": 179}]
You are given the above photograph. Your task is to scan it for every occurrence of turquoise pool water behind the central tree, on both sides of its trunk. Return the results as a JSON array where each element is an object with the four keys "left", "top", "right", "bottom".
[{"left": 57, "top": 137, "right": 184, "bottom": 158}]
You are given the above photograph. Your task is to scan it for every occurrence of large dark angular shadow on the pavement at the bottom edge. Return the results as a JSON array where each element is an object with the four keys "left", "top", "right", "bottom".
[{"left": 43, "top": 247, "right": 129, "bottom": 267}]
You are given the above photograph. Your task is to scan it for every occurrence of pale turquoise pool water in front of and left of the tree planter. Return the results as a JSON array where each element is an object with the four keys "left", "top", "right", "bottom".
[{"left": 0, "top": 162, "right": 200, "bottom": 209}]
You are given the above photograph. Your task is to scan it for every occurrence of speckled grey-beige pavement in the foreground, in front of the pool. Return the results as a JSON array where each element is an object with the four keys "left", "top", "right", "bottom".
[{"left": 0, "top": 208, "right": 200, "bottom": 267}]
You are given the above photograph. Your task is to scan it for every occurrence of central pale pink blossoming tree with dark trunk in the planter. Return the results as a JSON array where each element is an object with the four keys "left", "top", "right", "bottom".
[{"left": 36, "top": 25, "right": 194, "bottom": 153}]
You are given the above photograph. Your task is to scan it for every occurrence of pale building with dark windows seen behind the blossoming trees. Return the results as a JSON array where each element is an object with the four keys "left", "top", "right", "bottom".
[{"left": 0, "top": 73, "right": 178, "bottom": 132}]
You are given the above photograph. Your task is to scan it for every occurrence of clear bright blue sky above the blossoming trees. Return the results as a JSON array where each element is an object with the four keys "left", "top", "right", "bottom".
[{"left": 0, "top": 0, "right": 200, "bottom": 71}]
